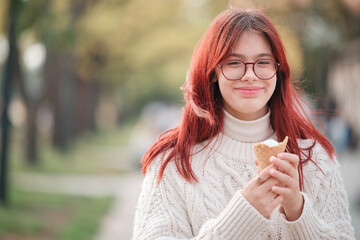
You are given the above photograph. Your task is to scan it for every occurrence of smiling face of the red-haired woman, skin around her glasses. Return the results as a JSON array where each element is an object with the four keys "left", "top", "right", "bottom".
[{"left": 216, "top": 31, "right": 276, "bottom": 121}]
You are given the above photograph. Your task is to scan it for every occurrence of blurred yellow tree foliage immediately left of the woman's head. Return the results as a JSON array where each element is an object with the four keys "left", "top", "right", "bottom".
[{"left": 78, "top": 0, "right": 227, "bottom": 119}]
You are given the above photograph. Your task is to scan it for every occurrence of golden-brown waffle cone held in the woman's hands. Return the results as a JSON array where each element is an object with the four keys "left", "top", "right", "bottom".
[{"left": 253, "top": 136, "right": 288, "bottom": 171}]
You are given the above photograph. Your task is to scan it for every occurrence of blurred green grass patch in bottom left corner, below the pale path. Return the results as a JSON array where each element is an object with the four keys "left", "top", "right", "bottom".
[{"left": 0, "top": 190, "right": 113, "bottom": 240}]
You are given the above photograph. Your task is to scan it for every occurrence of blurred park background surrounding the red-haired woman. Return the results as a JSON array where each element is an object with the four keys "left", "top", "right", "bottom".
[{"left": 0, "top": 0, "right": 360, "bottom": 240}]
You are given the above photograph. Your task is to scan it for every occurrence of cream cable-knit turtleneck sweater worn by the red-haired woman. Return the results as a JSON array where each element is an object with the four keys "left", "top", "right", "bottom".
[{"left": 133, "top": 112, "right": 355, "bottom": 240}]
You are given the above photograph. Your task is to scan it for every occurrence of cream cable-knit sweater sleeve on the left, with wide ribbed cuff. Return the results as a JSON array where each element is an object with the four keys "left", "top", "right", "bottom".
[{"left": 133, "top": 157, "right": 270, "bottom": 240}]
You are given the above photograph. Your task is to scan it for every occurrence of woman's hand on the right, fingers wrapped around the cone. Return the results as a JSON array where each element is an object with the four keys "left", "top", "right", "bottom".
[{"left": 269, "top": 153, "right": 304, "bottom": 221}]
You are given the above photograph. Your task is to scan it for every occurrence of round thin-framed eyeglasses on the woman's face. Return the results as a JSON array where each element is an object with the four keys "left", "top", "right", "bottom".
[{"left": 218, "top": 59, "right": 280, "bottom": 81}]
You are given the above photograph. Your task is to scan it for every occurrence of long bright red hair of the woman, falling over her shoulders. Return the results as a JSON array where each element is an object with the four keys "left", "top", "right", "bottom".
[{"left": 141, "top": 9, "right": 335, "bottom": 188}]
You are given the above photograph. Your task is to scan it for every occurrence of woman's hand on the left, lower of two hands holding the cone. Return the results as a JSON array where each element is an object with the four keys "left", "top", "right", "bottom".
[{"left": 242, "top": 165, "right": 282, "bottom": 218}]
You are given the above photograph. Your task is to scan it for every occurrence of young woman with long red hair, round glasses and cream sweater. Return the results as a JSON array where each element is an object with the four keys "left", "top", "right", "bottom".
[{"left": 133, "top": 6, "right": 354, "bottom": 240}]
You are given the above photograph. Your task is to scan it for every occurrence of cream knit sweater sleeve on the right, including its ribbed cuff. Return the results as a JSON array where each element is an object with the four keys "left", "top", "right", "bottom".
[{"left": 280, "top": 145, "right": 355, "bottom": 240}]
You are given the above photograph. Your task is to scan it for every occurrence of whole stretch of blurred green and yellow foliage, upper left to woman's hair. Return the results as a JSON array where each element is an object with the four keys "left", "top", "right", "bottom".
[{"left": 9, "top": 0, "right": 227, "bottom": 120}]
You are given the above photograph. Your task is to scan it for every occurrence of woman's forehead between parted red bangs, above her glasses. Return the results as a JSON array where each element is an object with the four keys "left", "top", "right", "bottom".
[{"left": 231, "top": 31, "right": 273, "bottom": 58}]
